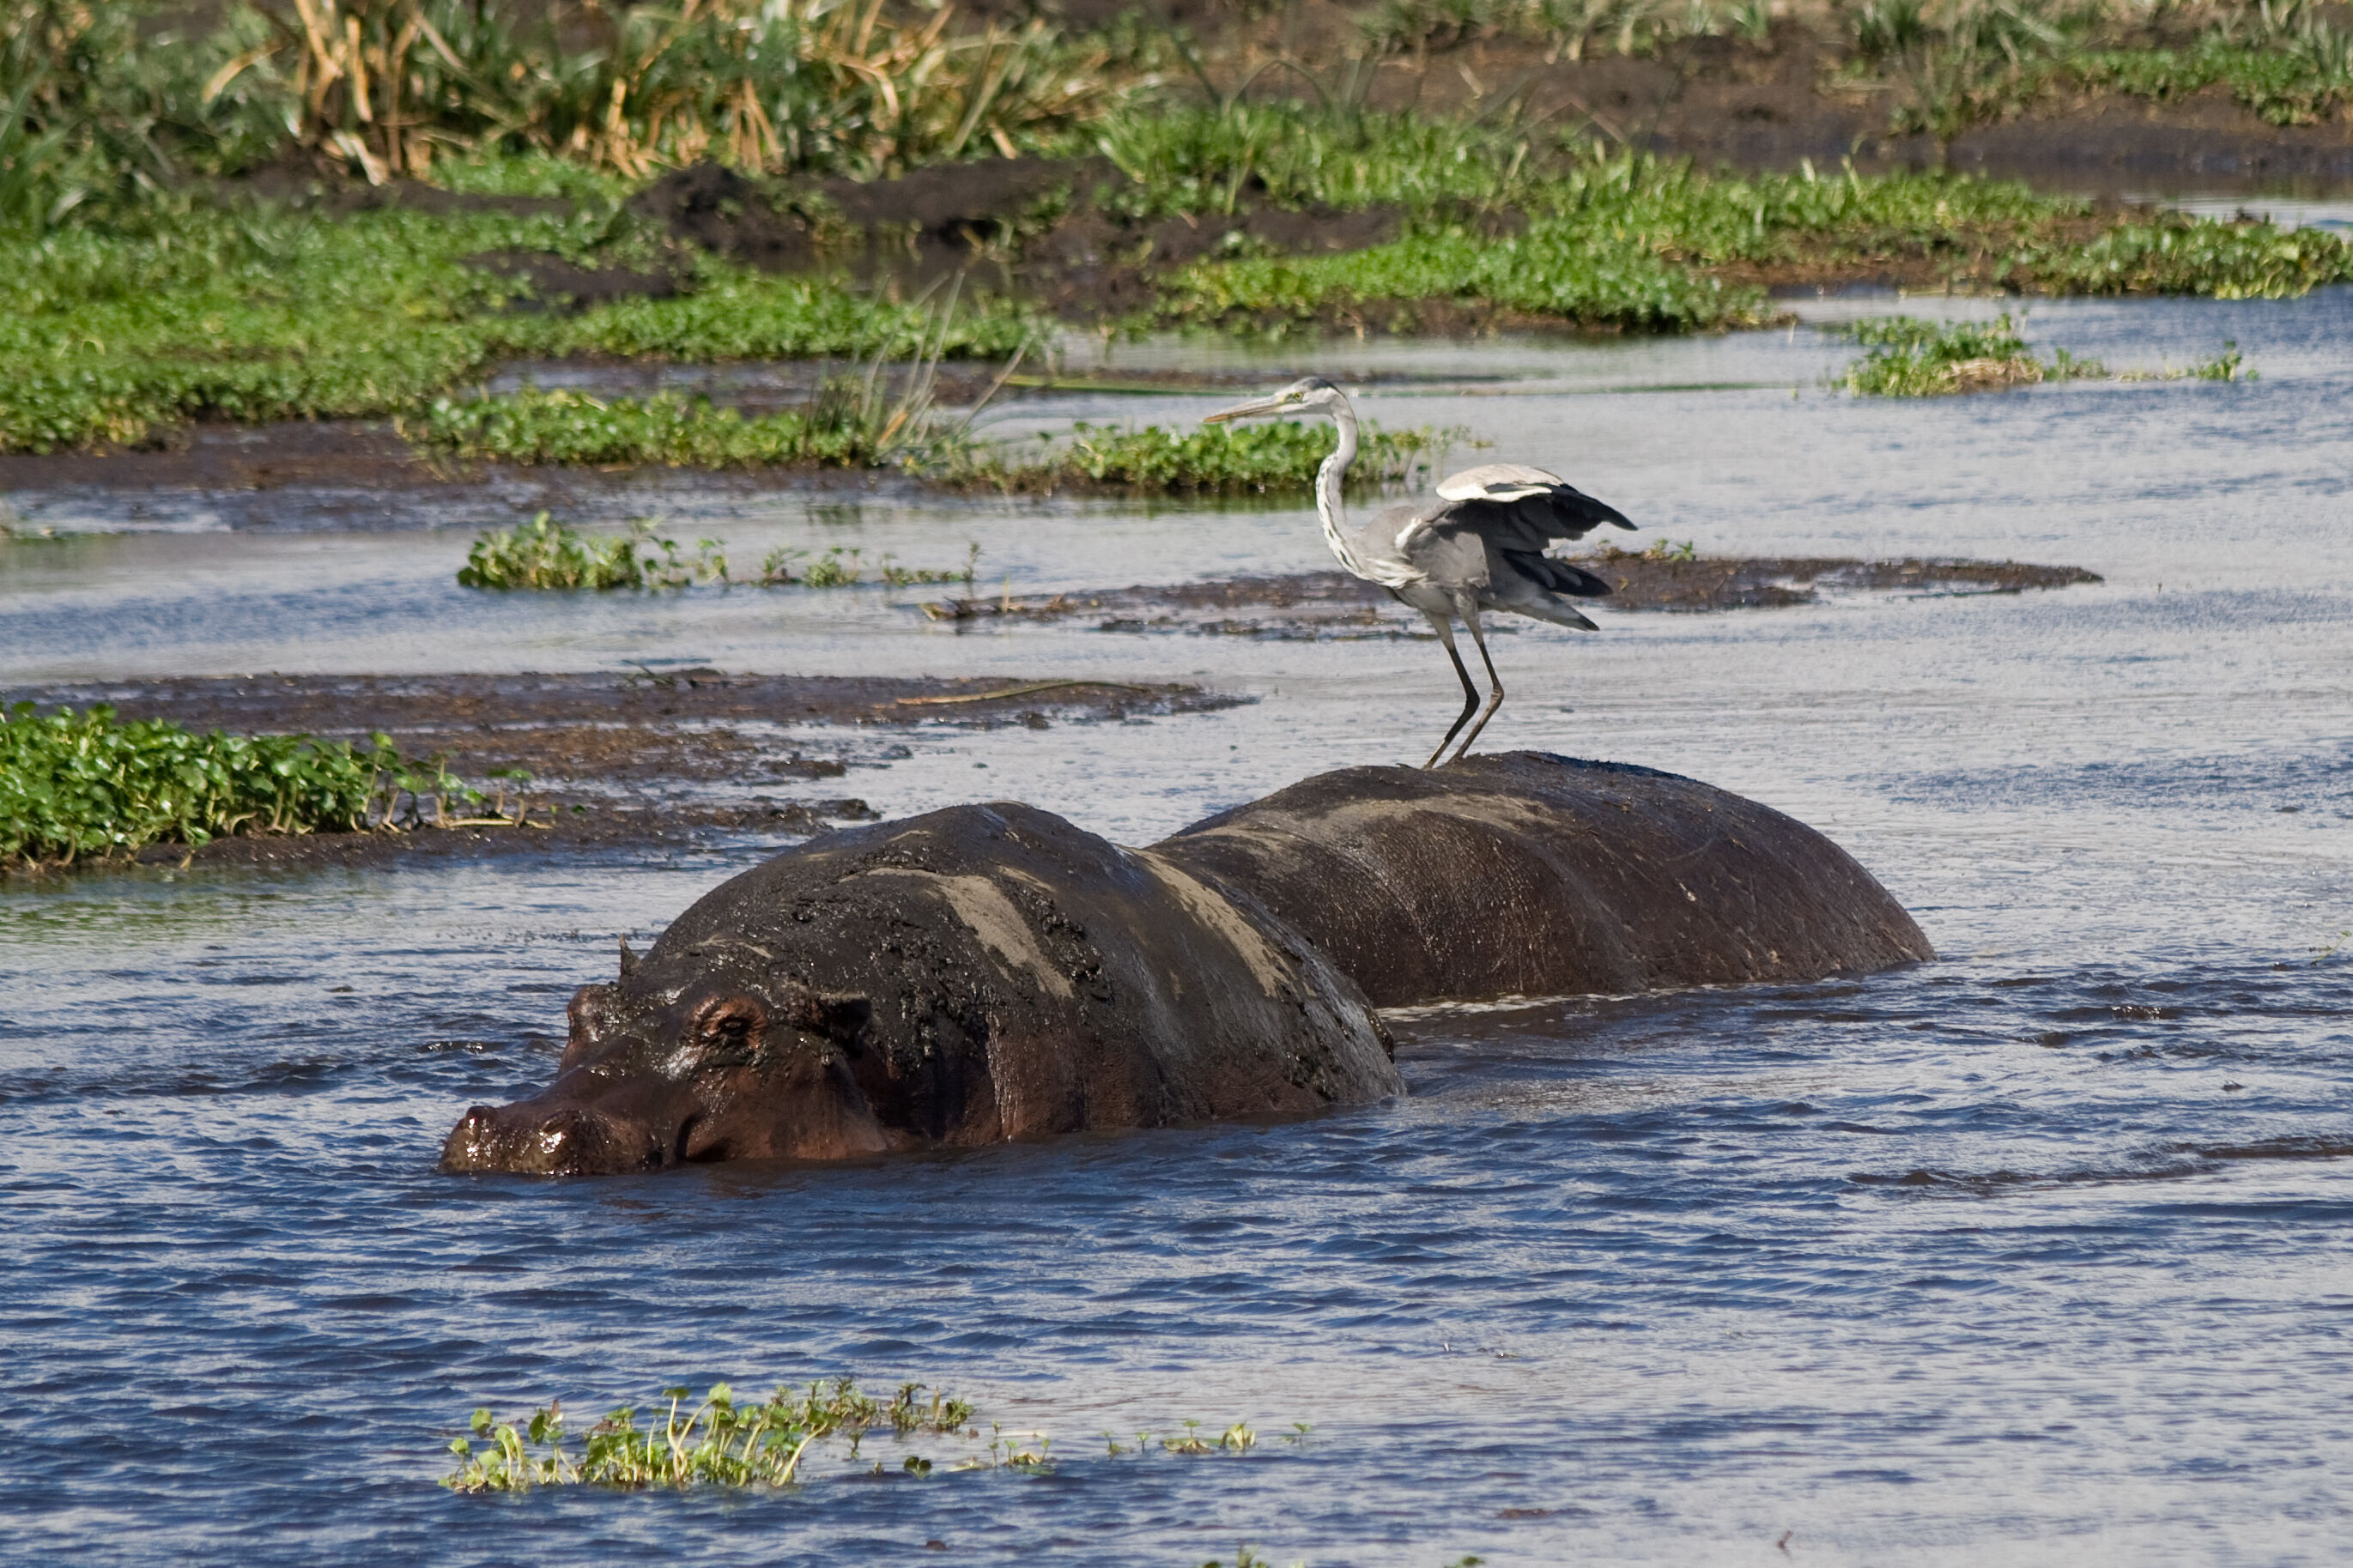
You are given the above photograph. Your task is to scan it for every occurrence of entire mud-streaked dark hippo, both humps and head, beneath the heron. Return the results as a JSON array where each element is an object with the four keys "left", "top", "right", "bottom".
[{"left": 442, "top": 753, "right": 1934, "bottom": 1176}]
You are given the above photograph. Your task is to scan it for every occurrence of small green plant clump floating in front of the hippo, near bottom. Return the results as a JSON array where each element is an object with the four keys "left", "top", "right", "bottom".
[{"left": 442, "top": 1377, "right": 972, "bottom": 1492}]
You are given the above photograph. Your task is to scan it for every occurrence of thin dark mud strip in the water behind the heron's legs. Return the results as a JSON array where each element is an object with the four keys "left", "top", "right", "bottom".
[{"left": 922, "top": 554, "right": 2101, "bottom": 639}]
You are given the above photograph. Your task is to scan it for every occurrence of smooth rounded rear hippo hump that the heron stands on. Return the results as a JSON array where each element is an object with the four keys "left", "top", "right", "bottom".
[{"left": 1155, "top": 753, "right": 1937, "bottom": 1006}]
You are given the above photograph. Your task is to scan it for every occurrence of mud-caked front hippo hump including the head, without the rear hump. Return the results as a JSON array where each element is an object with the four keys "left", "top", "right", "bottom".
[{"left": 442, "top": 804, "right": 1403, "bottom": 1173}]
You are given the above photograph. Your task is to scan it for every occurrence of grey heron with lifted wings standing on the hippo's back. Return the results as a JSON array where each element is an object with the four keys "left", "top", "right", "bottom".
[{"left": 1203, "top": 376, "right": 1633, "bottom": 769}]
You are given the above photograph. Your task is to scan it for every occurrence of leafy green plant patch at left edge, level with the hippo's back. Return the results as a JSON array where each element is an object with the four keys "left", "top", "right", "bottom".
[{"left": 0, "top": 703, "right": 480, "bottom": 869}]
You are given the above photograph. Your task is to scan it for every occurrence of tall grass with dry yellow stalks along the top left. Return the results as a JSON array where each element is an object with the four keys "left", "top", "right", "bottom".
[{"left": 0, "top": 0, "right": 1155, "bottom": 230}]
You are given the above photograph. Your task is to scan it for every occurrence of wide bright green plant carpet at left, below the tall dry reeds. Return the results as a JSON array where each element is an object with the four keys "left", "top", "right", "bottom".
[{"left": 0, "top": 195, "right": 1035, "bottom": 461}]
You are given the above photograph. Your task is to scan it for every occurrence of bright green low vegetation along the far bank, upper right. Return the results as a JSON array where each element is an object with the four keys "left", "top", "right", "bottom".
[{"left": 1134, "top": 123, "right": 2353, "bottom": 334}]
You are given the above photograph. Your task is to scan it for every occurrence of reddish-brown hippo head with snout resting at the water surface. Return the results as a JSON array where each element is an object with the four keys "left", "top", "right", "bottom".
[{"left": 442, "top": 945, "right": 892, "bottom": 1176}]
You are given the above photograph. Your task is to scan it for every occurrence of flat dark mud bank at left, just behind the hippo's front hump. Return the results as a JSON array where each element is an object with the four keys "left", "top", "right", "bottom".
[{"left": 0, "top": 668, "right": 1242, "bottom": 865}]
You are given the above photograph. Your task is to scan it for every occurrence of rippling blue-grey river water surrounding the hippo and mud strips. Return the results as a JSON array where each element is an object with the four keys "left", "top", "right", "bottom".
[{"left": 0, "top": 292, "right": 2353, "bottom": 1568}]
